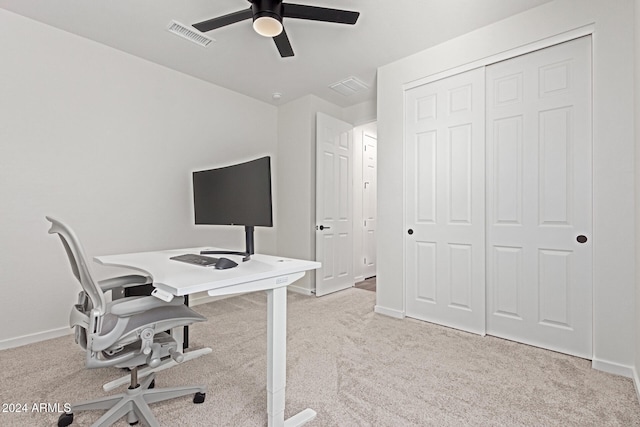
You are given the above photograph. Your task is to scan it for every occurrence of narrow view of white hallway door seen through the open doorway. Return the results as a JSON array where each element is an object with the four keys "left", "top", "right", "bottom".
[{"left": 362, "top": 132, "right": 378, "bottom": 279}]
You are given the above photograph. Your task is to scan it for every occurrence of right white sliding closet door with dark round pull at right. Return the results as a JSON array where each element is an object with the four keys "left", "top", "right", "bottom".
[{"left": 486, "top": 37, "right": 593, "bottom": 359}]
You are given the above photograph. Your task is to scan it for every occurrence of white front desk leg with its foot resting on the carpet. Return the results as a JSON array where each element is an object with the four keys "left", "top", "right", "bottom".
[{"left": 267, "top": 287, "right": 316, "bottom": 427}]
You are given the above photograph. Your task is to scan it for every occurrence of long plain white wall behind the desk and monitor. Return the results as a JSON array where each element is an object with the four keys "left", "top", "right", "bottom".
[{"left": 0, "top": 10, "right": 278, "bottom": 348}]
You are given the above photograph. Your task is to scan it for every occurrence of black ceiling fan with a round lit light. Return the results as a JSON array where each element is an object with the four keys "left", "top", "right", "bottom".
[{"left": 193, "top": 0, "right": 360, "bottom": 58}]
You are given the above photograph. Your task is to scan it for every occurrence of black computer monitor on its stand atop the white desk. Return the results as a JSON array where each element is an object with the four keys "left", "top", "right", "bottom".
[{"left": 193, "top": 156, "right": 273, "bottom": 259}]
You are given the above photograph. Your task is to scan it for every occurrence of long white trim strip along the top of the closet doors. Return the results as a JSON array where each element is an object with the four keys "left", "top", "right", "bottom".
[{"left": 402, "top": 24, "right": 595, "bottom": 92}]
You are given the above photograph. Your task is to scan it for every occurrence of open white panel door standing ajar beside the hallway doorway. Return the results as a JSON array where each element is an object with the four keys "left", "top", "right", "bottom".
[{"left": 316, "top": 113, "right": 354, "bottom": 296}]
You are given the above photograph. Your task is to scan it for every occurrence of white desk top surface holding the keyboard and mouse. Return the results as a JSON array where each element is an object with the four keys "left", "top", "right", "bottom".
[{"left": 94, "top": 247, "right": 320, "bottom": 295}]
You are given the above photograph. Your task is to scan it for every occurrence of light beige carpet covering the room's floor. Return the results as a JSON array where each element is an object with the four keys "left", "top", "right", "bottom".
[{"left": 0, "top": 288, "right": 640, "bottom": 427}]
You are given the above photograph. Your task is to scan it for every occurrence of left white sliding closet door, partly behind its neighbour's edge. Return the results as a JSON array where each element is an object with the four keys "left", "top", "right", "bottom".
[{"left": 405, "top": 68, "right": 485, "bottom": 334}]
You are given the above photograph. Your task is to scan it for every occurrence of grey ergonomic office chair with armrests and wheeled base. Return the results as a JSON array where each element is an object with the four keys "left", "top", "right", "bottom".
[{"left": 47, "top": 217, "right": 206, "bottom": 427}]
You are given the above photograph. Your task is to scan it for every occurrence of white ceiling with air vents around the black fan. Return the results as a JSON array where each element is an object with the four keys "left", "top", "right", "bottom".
[{"left": 0, "top": 0, "right": 551, "bottom": 107}]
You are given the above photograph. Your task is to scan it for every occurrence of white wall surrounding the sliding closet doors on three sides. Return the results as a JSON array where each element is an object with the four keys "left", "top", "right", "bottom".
[{"left": 376, "top": 0, "right": 636, "bottom": 375}]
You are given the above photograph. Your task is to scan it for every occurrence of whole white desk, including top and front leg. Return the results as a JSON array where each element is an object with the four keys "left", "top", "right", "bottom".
[{"left": 94, "top": 248, "right": 320, "bottom": 427}]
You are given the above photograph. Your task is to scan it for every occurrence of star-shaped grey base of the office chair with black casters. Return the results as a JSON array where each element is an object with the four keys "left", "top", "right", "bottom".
[{"left": 58, "top": 374, "right": 207, "bottom": 427}]
